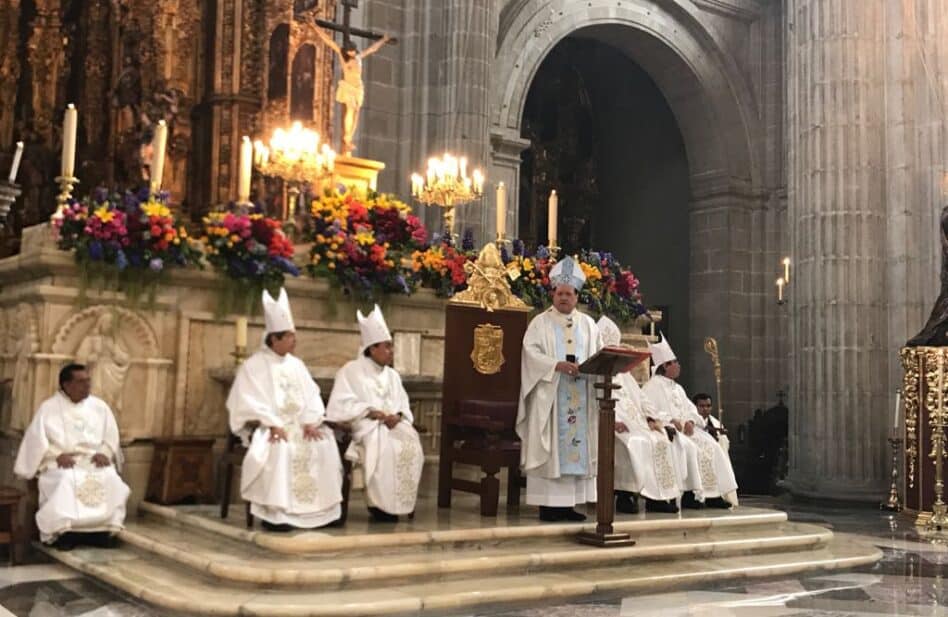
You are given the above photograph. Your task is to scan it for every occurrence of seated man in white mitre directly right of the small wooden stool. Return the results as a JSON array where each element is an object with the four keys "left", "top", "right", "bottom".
[{"left": 227, "top": 289, "right": 342, "bottom": 531}]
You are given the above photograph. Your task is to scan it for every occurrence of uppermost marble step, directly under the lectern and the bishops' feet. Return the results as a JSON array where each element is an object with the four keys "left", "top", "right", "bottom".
[{"left": 139, "top": 502, "right": 787, "bottom": 555}]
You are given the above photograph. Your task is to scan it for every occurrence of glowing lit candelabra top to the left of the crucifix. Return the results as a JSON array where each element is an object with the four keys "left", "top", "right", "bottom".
[{"left": 254, "top": 122, "right": 336, "bottom": 183}]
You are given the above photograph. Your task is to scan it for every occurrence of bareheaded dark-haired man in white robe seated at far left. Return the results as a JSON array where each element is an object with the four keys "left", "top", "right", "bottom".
[{"left": 13, "top": 364, "right": 130, "bottom": 550}]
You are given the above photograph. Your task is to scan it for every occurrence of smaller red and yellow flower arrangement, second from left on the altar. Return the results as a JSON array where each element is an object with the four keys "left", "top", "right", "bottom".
[{"left": 201, "top": 212, "right": 300, "bottom": 313}]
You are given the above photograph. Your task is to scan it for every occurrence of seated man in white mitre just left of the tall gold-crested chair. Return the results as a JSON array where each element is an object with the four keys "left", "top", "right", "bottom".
[{"left": 326, "top": 306, "right": 425, "bottom": 522}]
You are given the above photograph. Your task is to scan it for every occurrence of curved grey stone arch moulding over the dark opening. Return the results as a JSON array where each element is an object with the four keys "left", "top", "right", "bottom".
[{"left": 491, "top": 0, "right": 761, "bottom": 188}]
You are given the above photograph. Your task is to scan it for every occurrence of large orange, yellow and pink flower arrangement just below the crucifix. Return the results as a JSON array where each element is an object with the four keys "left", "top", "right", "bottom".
[{"left": 307, "top": 188, "right": 428, "bottom": 301}]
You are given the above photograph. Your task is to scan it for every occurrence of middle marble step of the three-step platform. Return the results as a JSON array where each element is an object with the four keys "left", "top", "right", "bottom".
[{"left": 115, "top": 521, "right": 833, "bottom": 587}]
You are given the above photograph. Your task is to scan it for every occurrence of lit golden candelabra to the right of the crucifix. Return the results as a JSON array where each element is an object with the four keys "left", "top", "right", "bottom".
[{"left": 411, "top": 153, "right": 482, "bottom": 241}]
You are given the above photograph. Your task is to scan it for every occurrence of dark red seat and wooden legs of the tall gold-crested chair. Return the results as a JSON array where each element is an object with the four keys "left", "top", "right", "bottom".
[{"left": 438, "top": 399, "right": 523, "bottom": 516}]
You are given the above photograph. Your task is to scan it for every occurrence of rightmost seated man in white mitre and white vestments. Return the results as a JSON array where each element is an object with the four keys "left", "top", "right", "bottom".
[{"left": 642, "top": 337, "right": 737, "bottom": 508}]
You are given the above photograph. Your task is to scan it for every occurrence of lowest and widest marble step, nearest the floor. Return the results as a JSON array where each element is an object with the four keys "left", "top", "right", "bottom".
[{"left": 37, "top": 537, "right": 881, "bottom": 617}]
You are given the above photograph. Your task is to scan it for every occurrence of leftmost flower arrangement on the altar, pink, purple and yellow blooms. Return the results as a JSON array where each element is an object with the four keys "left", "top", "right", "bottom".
[{"left": 52, "top": 189, "right": 201, "bottom": 301}]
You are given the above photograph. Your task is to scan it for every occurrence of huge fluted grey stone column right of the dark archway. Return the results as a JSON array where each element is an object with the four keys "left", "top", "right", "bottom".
[{"left": 786, "top": 0, "right": 891, "bottom": 501}]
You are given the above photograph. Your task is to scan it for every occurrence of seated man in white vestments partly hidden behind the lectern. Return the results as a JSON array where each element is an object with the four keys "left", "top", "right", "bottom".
[{"left": 596, "top": 315, "right": 681, "bottom": 514}]
